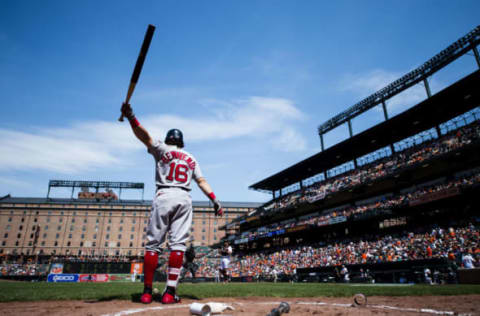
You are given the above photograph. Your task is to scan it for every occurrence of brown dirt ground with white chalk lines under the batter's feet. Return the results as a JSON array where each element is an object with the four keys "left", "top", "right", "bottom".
[{"left": 0, "top": 295, "right": 480, "bottom": 316}]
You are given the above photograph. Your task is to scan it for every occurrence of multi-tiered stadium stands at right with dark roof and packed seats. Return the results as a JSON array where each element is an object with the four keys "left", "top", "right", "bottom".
[{"left": 214, "top": 32, "right": 480, "bottom": 283}]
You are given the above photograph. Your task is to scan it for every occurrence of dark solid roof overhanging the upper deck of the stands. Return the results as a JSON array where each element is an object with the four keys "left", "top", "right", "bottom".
[{"left": 249, "top": 70, "right": 480, "bottom": 191}]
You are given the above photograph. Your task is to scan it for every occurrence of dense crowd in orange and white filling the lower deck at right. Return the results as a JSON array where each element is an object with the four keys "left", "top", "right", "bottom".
[{"left": 219, "top": 224, "right": 480, "bottom": 277}]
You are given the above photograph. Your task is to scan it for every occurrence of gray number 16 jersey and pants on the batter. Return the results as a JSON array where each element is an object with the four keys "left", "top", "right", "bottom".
[{"left": 145, "top": 141, "right": 202, "bottom": 252}]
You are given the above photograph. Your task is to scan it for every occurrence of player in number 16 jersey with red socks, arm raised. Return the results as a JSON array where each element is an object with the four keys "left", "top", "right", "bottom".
[{"left": 122, "top": 103, "right": 223, "bottom": 304}]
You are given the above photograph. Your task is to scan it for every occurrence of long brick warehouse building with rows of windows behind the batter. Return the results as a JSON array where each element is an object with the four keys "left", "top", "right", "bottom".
[{"left": 0, "top": 196, "right": 258, "bottom": 256}]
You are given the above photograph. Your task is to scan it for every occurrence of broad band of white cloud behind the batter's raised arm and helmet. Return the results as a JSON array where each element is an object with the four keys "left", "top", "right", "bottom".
[{"left": 0, "top": 97, "right": 306, "bottom": 174}]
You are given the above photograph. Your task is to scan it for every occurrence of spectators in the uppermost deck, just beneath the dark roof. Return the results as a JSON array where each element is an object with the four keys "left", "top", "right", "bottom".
[{"left": 256, "top": 121, "right": 480, "bottom": 216}]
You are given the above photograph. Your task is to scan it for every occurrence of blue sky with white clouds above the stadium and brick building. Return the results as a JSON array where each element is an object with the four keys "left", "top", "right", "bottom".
[{"left": 0, "top": 0, "right": 480, "bottom": 202}]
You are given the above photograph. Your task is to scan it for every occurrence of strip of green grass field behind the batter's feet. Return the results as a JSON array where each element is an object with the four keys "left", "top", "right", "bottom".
[{"left": 0, "top": 282, "right": 480, "bottom": 302}]
